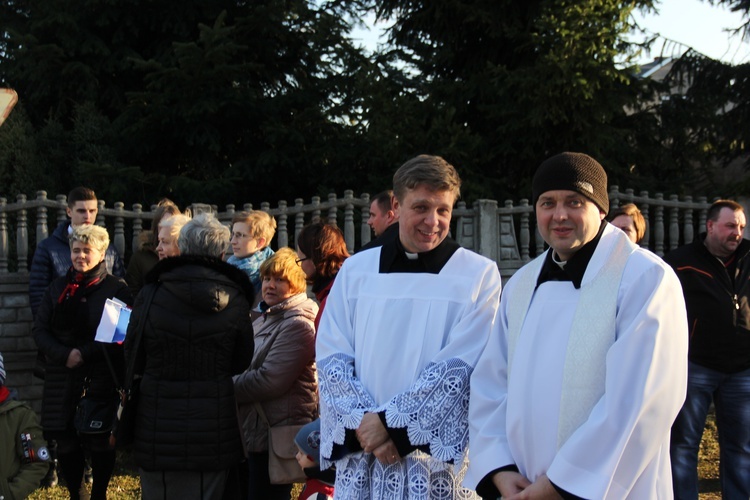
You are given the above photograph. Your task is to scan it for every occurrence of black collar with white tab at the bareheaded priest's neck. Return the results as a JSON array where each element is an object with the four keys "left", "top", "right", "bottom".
[{"left": 380, "top": 233, "right": 460, "bottom": 274}]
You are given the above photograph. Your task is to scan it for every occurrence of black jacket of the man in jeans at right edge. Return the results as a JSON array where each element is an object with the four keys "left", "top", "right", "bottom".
[{"left": 664, "top": 233, "right": 750, "bottom": 373}]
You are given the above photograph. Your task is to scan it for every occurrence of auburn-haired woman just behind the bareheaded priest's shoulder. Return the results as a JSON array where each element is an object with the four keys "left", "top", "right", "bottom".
[{"left": 297, "top": 222, "right": 349, "bottom": 331}]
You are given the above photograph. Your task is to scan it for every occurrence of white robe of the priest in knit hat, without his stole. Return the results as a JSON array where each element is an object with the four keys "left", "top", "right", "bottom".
[{"left": 465, "top": 227, "right": 688, "bottom": 499}]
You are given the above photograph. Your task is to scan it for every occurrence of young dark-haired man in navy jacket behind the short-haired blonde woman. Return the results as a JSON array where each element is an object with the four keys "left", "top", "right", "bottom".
[{"left": 29, "top": 187, "right": 125, "bottom": 314}]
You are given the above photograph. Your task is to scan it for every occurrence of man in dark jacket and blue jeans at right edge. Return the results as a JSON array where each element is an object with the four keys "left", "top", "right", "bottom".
[{"left": 664, "top": 200, "right": 750, "bottom": 499}]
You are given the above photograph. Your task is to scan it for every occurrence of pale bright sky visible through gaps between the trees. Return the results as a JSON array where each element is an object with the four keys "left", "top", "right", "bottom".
[{"left": 352, "top": 0, "right": 750, "bottom": 64}]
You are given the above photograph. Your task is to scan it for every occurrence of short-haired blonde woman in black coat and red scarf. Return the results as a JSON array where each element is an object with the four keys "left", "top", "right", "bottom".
[{"left": 33, "top": 225, "right": 132, "bottom": 500}]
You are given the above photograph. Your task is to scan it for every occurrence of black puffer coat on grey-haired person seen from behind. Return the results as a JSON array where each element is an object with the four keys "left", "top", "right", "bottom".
[{"left": 125, "top": 256, "right": 253, "bottom": 471}]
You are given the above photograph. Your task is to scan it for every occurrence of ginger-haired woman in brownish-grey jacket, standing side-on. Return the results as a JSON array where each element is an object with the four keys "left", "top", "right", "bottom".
[{"left": 234, "top": 248, "right": 318, "bottom": 500}]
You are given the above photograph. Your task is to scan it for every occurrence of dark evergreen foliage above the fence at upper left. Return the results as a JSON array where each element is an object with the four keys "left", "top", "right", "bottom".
[{"left": 0, "top": 0, "right": 364, "bottom": 207}]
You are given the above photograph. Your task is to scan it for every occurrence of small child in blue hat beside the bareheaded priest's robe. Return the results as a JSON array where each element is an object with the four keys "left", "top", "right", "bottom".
[{"left": 294, "top": 419, "right": 336, "bottom": 500}]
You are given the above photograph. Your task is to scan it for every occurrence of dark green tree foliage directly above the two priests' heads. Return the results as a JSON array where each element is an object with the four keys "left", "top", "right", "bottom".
[{"left": 352, "top": 0, "right": 680, "bottom": 198}]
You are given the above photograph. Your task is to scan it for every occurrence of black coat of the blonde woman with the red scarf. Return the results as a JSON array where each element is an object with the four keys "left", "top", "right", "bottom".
[{"left": 33, "top": 264, "right": 132, "bottom": 431}]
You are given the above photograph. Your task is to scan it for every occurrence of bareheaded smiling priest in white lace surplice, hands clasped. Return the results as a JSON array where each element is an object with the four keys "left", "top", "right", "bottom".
[{"left": 316, "top": 155, "right": 500, "bottom": 500}]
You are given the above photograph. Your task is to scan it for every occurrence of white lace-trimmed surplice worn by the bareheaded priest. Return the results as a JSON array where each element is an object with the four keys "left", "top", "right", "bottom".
[{"left": 316, "top": 248, "right": 501, "bottom": 499}]
